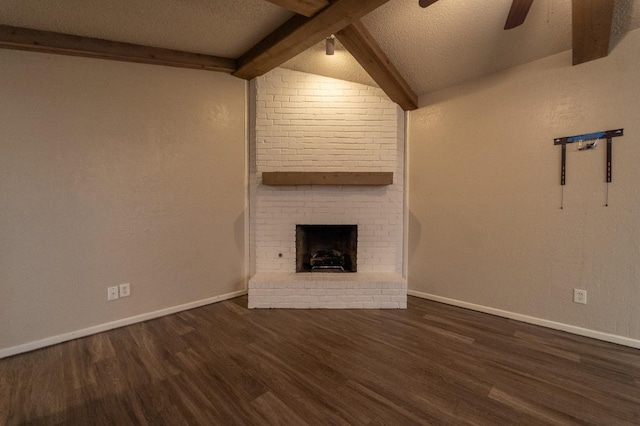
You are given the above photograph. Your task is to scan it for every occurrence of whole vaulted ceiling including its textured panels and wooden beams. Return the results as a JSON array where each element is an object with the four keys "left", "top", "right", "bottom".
[{"left": 0, "top": 0, "right": 640, "bottom": 110}]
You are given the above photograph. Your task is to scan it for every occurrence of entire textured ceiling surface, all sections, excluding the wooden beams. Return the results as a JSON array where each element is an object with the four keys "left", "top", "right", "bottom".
[{"left": 0, "top": 0, "right": 640, "bottom": 95}]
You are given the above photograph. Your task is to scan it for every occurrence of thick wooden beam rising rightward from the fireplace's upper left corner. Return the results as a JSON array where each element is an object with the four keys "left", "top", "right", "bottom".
[{"left": 233, "top": 0, "right": 388, "bottom": 80}]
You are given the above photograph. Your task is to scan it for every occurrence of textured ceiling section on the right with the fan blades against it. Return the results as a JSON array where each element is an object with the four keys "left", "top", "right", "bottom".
[{"left": 363, "top": 0, "right": 571, "bottom": 94}]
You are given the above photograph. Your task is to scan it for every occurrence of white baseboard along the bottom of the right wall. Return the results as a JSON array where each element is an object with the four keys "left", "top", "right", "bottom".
[{"left": 407, "top": 290, "right": 640, "bottom": 349}]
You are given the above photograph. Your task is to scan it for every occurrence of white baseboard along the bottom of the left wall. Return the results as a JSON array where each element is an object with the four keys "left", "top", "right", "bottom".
[{"left": 0, "top": 290, "right": 247, "bottom": 359}]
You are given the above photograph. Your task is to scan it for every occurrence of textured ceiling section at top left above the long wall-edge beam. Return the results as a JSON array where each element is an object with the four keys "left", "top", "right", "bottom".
[{"left": 0, "top": 0, "right": 293, "bottom": 58}]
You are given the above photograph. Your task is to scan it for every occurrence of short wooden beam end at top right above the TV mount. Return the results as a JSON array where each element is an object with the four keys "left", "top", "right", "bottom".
[{"left": 571, "top": 0, "right": 614, "bottom": 65}]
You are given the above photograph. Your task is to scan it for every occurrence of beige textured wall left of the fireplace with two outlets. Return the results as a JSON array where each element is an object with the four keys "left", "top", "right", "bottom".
[{"left": 0, "top": 50, "right": 246, "bottom": 352}]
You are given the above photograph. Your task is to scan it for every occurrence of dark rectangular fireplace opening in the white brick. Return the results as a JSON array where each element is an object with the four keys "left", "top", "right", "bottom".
[{"left": 296, "top": 225, "right": 358, "bottom": 272}]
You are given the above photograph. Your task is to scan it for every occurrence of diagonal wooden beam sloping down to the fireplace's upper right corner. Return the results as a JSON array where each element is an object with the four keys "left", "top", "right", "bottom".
[{"left": 336, "top": 21, "right": 418, "bottom": 111}]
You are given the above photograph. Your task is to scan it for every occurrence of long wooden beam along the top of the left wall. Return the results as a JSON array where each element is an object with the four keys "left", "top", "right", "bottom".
[{"left": 0, "top": 25, "right": 236, "bottom": 73}]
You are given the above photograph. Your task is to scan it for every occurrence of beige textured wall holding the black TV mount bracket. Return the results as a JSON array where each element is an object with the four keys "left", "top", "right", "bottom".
[{"left": 409, "top": 30, "right": 640, "bottom": 339}]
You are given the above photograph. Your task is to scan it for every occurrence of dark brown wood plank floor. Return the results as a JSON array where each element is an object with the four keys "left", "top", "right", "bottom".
[{"left": 0, "top": 297, "right": 640, "bottom": 426}]
